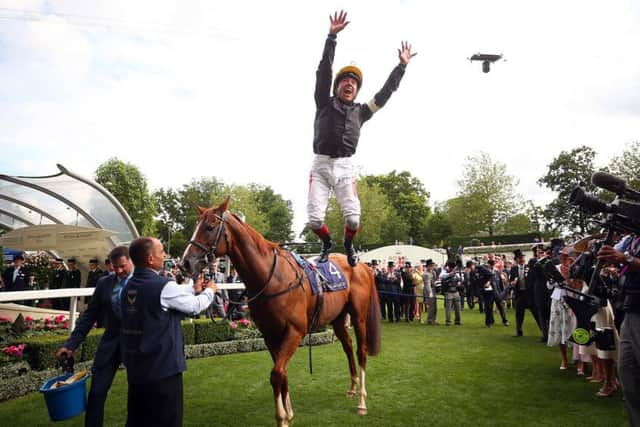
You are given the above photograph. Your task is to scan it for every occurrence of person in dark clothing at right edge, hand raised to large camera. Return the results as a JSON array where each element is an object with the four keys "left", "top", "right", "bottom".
[{"left": 598, "top": 234, "right": 640, "bottom": 426}]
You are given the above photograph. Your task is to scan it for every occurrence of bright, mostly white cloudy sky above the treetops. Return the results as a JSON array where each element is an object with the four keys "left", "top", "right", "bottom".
[{"left": 0, "top": 0, "right": 640, "bottom": 234}]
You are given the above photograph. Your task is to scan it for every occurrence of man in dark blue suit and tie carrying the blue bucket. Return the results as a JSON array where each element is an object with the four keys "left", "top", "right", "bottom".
[{"left": 56, "top": 246, "right": 133, "bottom": 426}]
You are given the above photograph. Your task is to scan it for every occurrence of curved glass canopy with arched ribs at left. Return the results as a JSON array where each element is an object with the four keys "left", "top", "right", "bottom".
[{"left": 0, "top": 164, "right": 138, "bottom": 249}]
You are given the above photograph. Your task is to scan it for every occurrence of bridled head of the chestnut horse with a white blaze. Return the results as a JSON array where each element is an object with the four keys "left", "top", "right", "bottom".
[{"left": 180, "top": 197, "right": 229, "bottom": 277}]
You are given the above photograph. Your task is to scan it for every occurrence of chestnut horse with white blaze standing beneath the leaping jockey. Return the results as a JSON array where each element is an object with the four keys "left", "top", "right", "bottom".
[{"left": 182, "top": 198, "right": 380, "bottom": 426}]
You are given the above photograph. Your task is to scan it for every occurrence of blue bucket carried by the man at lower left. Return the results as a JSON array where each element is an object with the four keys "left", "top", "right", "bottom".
[{"left": 40, "top": 373, "right": 89, "bottom": 421}]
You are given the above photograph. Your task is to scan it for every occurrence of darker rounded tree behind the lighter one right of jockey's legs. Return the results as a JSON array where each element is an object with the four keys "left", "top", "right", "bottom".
[{"left": 361, "top": 170, "right": 431, "bottom": 241}]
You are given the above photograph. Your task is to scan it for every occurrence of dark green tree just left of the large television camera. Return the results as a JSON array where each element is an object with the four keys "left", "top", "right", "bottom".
[{"left": 538, "top": 145, "right": 596, "bottom": 233}]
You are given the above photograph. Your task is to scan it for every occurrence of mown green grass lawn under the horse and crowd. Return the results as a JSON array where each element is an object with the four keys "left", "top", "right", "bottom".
[{"left": 0, "top": 302, "right": 628, "bottom": 427}]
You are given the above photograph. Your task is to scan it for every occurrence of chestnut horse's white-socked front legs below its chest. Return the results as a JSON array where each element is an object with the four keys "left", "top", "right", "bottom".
[{"left": 271, "top": 331, "right": 301, "bottom": 427}]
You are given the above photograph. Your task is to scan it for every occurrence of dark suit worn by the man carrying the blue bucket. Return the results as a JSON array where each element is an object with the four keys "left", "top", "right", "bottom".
[{"left": 64, "top": 274, "right": 121, "bottom": 426}]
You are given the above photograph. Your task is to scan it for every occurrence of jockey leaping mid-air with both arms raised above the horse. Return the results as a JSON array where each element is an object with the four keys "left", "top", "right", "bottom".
[{"left": 307, "top": 11, "right": 416, "bottom": 266}]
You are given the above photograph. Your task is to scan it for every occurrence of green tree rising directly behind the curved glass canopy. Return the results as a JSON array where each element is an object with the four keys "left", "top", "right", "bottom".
[{"left": 95, "top": 157, "right": 156, "bottom": 235}]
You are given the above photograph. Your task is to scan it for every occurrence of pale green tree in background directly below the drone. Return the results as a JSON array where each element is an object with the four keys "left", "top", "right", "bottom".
[{"left": 452, "top": 152, "right": 522, "bottom": 236}]
